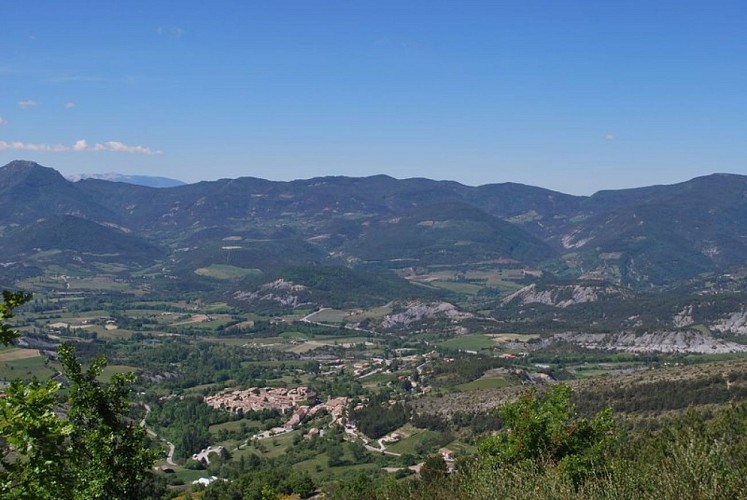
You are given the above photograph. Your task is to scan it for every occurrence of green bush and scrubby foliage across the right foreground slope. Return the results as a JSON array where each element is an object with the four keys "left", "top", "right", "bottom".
[{"left": 331, "top": 389, "right": 747, "bottom": 500}]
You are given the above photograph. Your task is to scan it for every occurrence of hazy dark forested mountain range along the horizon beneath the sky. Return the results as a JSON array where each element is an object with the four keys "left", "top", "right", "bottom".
[{"left": 0, "top": 161, "right": 747, "bottom": 296}]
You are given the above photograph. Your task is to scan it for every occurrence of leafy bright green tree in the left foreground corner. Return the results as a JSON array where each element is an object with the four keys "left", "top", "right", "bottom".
[{"left": 0, "top": 291, "right": 158, "bottom": 499}]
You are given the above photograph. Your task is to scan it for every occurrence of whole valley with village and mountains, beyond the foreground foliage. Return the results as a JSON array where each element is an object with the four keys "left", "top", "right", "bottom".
[{"left": 0, "top": 162, "right": 747, "bottom": 498}]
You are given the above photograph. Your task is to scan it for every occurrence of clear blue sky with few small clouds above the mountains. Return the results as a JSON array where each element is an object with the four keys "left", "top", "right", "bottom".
[{"left": 0, "top": 0, "right": 747, "bottom": 195}]
